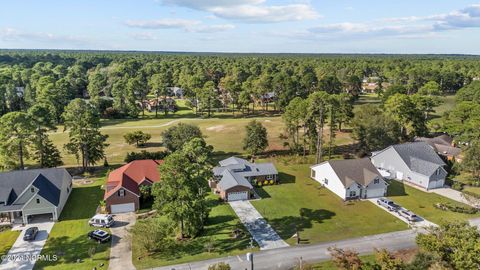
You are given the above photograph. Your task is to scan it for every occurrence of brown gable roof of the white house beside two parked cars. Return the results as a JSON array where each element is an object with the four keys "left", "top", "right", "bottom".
[{"left": 327, "top": 158, "right": 383, "bottom": 187}]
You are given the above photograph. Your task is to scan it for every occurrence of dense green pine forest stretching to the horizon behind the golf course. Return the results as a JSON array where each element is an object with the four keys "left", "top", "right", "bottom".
[{"left": 0, "top": 50, "right": 480, "bottom": 172}]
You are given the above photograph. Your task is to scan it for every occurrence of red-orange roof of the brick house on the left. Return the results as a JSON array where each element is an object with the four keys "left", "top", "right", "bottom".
[{"left": 104, "top": 159, "right": 163, "bottom": 199}]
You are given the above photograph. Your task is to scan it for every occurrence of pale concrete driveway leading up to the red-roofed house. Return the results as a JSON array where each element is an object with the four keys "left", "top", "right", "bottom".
[{"left": 108, "top": 213, "right": 137, "bottom": 270}]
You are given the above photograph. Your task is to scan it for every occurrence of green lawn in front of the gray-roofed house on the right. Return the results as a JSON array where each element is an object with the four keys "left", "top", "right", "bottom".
[{"left": 388, "top": 180, "right": 480, "bottom": 224}]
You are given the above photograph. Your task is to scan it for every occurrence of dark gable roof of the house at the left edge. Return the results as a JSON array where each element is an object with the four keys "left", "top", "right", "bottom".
[{"left": 0, "top": 168, "right": 71, "bottom": 210}]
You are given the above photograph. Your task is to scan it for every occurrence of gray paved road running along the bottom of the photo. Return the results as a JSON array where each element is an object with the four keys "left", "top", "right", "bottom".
[{"left": 154, "top": 230, "right": 416, "bottom": 270}]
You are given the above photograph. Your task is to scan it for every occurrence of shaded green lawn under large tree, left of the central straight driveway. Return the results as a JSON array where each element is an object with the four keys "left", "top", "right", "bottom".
[{"left": 133, "top": 195, "right": 257, "bottom": 269}]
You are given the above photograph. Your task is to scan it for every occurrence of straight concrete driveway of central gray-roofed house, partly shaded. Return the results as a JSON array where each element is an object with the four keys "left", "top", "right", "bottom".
[{"left": 229, "top": 201, "right": 288, "bottom": 250}]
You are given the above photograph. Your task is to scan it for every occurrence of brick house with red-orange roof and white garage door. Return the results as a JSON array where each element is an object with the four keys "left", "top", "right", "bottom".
[{"left": 104, "top": 159, "right": 163, "bottom": 214}]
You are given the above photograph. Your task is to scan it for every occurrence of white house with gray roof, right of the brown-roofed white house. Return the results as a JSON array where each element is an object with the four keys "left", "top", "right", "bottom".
[{"left": 371, "top": 142, "right": 447, "bottom": 190}]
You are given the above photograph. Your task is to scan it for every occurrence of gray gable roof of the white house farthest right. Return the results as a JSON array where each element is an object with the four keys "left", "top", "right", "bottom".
[{"left": 387, "top": 142, "right": 446, "bottom": 176}]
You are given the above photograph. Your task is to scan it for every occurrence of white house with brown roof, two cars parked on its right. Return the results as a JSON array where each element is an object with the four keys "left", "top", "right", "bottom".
[{"left": 310, "top": 158, "right": 388, "bottom": 200}]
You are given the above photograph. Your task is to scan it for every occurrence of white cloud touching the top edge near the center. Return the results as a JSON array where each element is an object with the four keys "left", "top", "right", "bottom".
[{"left": 163, "top": 0, "right": 320, "bottom": 23}]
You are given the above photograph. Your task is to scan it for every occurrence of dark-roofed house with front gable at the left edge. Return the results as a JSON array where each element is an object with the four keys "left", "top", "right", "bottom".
[{"left": 0, "top": 168, "right": 72, "bottom": 224}]
